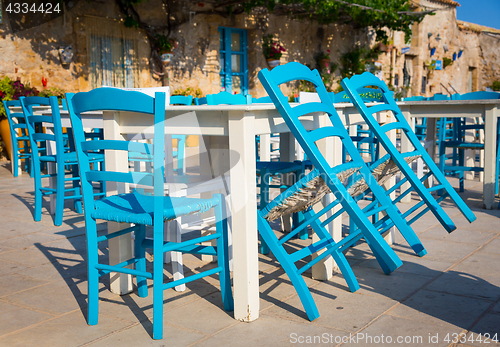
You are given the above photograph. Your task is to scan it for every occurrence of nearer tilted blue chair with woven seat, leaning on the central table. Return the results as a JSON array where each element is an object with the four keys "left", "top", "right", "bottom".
[{"left": 257, "top": 63, "right": 426, "bottom": 320}]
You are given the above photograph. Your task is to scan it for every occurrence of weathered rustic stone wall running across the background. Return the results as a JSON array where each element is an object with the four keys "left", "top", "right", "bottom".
[{"left": 0, "top": 0, "right": 500, "bottom": 97}]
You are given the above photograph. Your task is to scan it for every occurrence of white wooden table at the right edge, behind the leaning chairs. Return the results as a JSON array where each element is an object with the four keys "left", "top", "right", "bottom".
[{"left": 397, "top": 100, "right": 500, "bottom": 210}]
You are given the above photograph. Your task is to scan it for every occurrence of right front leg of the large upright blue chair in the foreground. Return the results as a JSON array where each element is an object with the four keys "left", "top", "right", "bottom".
[{"left": 214, "top": 194, "right": 234, "bottom": 311}]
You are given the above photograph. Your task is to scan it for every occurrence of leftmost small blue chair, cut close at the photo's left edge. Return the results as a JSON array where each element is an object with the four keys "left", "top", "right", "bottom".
[{"left": 2, "top": 100, "right": 33, "bottom": 177}]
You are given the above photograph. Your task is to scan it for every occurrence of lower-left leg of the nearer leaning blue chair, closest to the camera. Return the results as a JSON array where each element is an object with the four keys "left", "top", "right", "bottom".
[{"left": 257, "top": 215, "right": 319, "bottom": 321}]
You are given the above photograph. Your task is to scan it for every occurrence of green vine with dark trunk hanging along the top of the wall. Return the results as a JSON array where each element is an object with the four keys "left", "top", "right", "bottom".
[{"left": 111, "top": 0, "right": 433, "bottom": 76}]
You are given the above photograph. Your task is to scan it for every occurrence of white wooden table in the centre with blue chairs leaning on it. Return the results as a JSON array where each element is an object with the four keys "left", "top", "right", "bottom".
[{"left": 98, "top": 104, "right": 341, "bottom": 321}]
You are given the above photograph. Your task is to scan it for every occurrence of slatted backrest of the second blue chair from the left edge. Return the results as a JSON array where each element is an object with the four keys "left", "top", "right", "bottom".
[{"left": 19, "top": 96, "right": 64, "bottom": 165}]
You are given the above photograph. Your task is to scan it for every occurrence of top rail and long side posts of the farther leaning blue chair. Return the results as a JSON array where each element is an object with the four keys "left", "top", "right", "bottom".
[{"left": 341, "top": 72, "right": 476, "bottom": 232}]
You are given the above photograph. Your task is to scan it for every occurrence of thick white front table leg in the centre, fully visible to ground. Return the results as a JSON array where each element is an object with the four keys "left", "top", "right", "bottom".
[{"left": 228, "top": 111, "right": 259, "bottom": 322}]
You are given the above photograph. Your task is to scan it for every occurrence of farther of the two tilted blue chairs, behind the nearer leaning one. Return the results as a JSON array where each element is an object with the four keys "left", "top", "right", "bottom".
[{"left": 341, "top": 72, "right": 476, "bottom": 232}]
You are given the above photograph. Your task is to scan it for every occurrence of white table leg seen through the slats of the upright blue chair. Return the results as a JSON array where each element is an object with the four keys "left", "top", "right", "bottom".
[{"left": 103, "top": 112, "right": 132, "bottom": 295}]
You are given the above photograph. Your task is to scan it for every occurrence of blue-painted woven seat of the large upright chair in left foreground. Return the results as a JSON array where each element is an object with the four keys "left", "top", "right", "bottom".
[{"left": 91, "top": 190, "right": 218, "bottom": 225}]
